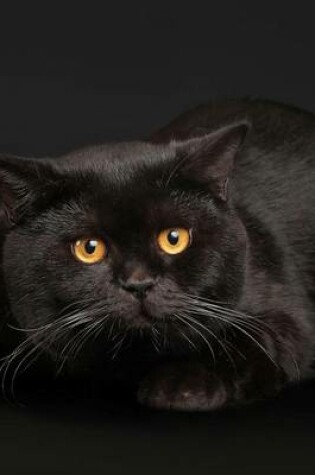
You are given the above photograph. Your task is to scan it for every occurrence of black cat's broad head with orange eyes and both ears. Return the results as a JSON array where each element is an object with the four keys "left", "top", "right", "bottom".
[{"left": 0, "top": 123, "right": 247, "bottom": 354}]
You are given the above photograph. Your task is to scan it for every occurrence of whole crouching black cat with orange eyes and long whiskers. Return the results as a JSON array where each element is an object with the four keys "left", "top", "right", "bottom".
[{"left": 0, "top": 100, "right": 315, "bottom": 410}]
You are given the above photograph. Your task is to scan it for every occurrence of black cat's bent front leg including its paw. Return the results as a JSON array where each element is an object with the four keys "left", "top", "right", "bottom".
[{"left": 138, "top": 315, "right": 311, "bottom": 410}]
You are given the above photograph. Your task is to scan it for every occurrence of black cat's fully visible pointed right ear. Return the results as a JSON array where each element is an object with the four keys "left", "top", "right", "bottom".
[{"left": 172, "top": 121, "right": 250, "bottom": 201}]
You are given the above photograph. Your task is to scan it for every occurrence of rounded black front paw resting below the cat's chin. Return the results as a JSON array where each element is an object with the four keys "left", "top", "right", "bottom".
[{"left": 138, "top": 363, "right": 228, "bottom": 411}]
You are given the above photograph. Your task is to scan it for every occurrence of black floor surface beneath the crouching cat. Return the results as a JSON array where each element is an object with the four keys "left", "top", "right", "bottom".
[{"left": 0, "top": 384, "right": 315, "bottom": 475}]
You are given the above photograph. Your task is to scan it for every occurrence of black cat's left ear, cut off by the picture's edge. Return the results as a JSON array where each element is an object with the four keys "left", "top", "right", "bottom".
[{"left": 0, "top": 156, "right": 54, "bottom": 230}]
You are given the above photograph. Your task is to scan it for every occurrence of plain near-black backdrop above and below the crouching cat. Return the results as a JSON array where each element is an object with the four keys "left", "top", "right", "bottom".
[{"left": 0, "top": 1, "right": 315, "bottom": 475}]
